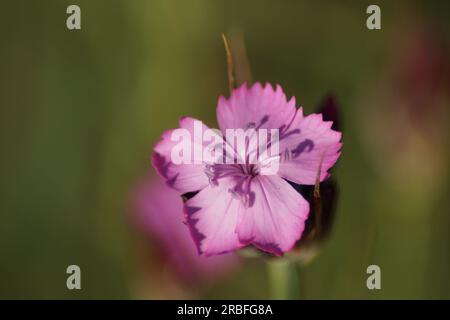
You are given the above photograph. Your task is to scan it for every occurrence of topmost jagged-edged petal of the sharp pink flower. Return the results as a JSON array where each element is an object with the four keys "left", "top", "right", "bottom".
[{"left": 217, "top": 82, "right": 295, "bottom": 135}]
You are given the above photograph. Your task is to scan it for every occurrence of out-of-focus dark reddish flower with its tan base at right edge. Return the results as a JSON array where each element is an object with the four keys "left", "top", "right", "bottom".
[{"left": 357, "top": 23, "right": 450, "bottom": 198}]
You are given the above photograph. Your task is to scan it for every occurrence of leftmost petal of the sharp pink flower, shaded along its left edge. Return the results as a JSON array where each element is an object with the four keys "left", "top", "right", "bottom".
[{"left": 152, "top": 117, "right": 209, "bottom": 193}]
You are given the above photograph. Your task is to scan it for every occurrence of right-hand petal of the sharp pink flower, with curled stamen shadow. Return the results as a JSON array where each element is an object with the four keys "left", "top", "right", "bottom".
[{"left": 278, "top": 108, "right": 342, "bottom": 185}]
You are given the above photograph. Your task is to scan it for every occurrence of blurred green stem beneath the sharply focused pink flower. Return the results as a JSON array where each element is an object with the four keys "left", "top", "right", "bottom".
[{"left": 267, "top": 260, "right": 299, "bottom": 300}]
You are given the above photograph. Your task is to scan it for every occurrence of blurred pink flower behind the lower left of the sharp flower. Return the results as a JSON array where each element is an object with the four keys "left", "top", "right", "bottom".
[{"left": 133, "top": 176, "right": 238, "bottom": 283}]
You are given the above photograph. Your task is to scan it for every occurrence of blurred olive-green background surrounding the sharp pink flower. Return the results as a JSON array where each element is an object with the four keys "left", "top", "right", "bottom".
[{"left": 0, "top": 0, "right": 450, "bottom": 299}]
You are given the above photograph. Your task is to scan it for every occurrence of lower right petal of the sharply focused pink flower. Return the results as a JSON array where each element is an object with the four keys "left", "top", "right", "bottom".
[{"left": 237, "top": 176, "right": 309, "bottom": 255}]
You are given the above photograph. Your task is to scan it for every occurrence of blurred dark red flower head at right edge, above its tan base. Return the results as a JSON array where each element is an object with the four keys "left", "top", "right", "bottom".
[{"left": 387, "top": 24, "right": 450, "bottom": 131}]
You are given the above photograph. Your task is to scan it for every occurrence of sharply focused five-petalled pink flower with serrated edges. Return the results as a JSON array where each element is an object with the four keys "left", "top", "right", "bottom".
[{"left": 152, "top": 83, "right": 342, "bottom": 256}]
